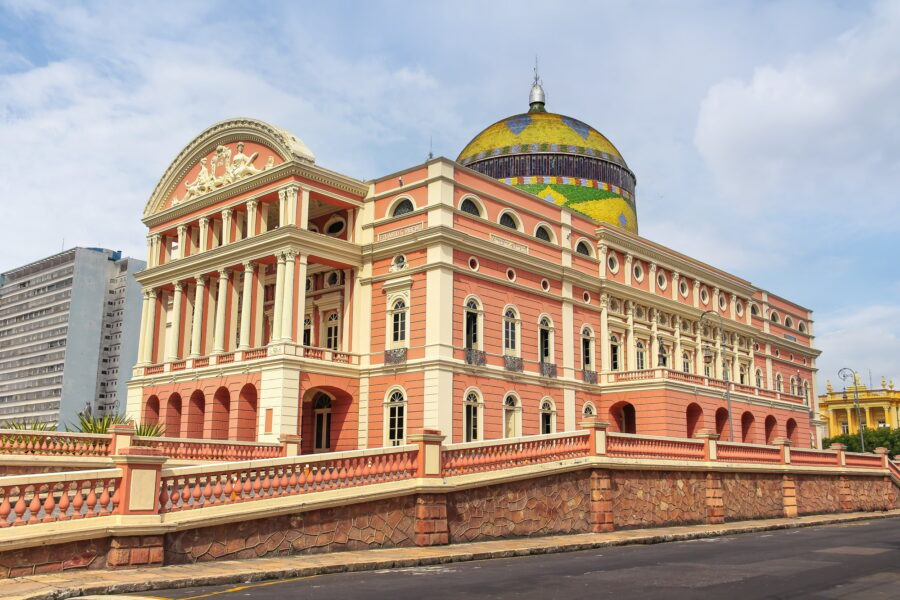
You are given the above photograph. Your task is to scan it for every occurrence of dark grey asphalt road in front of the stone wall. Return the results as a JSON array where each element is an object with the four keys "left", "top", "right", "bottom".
[{"left": 137, "top": 518, "right": 900, "bottom": 600}]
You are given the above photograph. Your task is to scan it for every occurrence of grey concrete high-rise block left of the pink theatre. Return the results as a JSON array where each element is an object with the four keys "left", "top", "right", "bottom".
[{"left": 0, "top": 248, "right": 145, "bottom": 427}]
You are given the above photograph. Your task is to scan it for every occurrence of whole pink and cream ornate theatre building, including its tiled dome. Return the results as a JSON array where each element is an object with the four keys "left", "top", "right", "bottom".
[{"left": 128, "top": 83, "right": 818, "bottom": 452}]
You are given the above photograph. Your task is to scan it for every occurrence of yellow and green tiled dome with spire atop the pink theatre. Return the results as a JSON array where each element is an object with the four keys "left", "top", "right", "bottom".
[{"left": 457, "top": 81, "right": 638, "bottom": 233}]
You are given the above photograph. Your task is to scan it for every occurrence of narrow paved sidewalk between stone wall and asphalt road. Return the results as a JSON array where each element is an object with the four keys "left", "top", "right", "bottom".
[{"left": 12, "top": 510, "right": 900, "bottom": 600}]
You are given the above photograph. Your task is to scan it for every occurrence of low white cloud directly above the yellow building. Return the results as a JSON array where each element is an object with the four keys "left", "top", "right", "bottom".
[{"left": 816, "top": 304, "right": 900, "bottom": 393}]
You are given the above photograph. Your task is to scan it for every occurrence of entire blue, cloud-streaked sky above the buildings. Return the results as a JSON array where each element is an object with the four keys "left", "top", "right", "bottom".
[{"left": 0, "top": 0, "right": 900, "bottom": 391}]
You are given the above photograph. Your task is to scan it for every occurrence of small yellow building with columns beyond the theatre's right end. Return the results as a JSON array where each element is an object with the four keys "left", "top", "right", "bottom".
[{"left": 819, "top": 375, "right": 900, "bottom": 437}]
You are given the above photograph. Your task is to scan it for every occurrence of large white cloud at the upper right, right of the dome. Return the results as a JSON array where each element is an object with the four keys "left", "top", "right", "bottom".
[{"left": 694, "top": 2, "right": 900, "bottom": 225}]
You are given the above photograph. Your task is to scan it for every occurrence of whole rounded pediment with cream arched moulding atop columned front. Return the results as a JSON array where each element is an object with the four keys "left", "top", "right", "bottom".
[{"left": 144, "top": 119, "right": 316, "bottom": 218}]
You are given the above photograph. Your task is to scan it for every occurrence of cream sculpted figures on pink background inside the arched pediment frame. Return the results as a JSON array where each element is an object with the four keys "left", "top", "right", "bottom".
[{"left": 169, "top": 142, "right": 283, "bottom": 206}]
